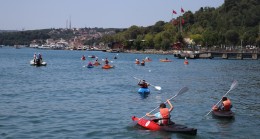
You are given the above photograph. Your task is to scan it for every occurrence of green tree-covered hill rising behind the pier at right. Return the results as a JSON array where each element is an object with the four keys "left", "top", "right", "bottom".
[{"left": 102, "top": 0, "right": 260, "bottom": 50}]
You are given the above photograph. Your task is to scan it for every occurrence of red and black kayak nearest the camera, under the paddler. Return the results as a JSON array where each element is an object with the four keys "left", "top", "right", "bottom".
[{"left": 132, "top": 116, "right": 197, "bottom": 135}]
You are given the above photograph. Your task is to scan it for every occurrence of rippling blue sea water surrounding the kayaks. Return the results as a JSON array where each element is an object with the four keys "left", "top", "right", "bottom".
[{"left": 0, "top": 47, "right": 260, "bottom": 139}]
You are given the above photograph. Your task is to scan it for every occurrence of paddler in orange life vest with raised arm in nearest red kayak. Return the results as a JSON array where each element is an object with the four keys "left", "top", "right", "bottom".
[{"left": 146, "top": 99, "right": 174, "bottom": 125}]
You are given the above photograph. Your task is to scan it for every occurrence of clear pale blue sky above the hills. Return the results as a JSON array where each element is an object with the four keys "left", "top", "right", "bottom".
[{"left": 0, "top": 0, "right": 224, "bottom": 30}]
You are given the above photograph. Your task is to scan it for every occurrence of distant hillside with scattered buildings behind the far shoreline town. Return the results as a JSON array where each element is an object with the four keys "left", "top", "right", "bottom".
[{"left": 0, "top": 28, "right": 122, "bottom": 46}]
